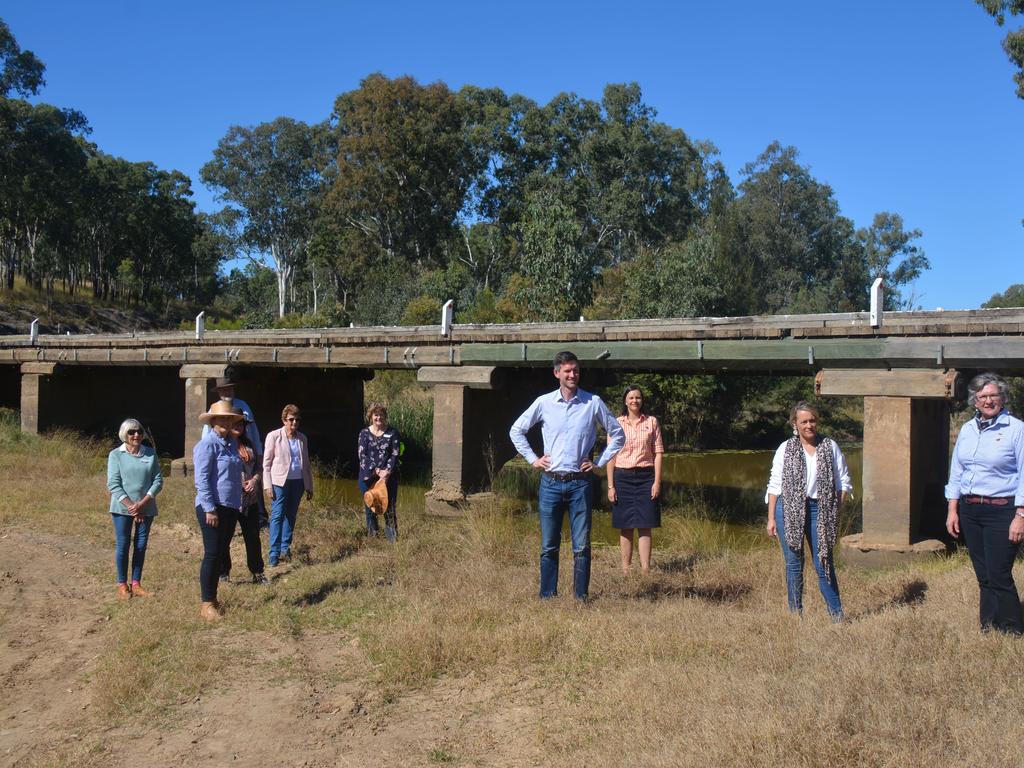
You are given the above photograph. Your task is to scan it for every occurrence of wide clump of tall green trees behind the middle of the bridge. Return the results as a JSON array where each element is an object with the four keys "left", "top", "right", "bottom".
[{"left": 201, "top": 75, "right": 929, "bottom": 325}]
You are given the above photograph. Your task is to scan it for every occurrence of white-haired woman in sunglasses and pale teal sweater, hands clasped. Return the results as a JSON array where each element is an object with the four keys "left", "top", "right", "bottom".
[{"left": 106, "top": 419, "right": 164, "bottom": 600}]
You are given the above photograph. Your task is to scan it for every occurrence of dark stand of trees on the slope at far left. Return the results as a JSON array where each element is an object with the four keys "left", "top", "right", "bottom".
[{"left": 0, "top": 20, "right": 224, "bottom": 305}]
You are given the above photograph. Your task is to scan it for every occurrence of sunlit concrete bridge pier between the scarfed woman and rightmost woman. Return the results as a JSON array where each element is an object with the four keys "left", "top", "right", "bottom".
[{"left": 817, "top": 370, "right": 959, "bottom": 567}]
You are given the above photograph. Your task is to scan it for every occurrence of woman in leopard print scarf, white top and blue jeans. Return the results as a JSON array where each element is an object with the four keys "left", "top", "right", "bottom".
[{"left": 765, "top": 402, "right": 853, "bottom": 622}]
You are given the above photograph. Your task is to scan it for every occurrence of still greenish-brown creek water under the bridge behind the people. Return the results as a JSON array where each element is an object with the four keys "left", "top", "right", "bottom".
[{"left": 318, "top": 445, "right": 862, "bottom": 546}]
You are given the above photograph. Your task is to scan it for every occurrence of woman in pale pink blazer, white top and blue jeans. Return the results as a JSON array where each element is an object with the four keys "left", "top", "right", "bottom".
[{"left": 263, "top": 404, "right": 313, "bottom": 567}]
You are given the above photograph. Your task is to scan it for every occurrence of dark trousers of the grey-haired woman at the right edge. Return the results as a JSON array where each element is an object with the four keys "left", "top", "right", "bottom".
[{"left": 959, "top": 499, "right": 1024, "bottom": 635}]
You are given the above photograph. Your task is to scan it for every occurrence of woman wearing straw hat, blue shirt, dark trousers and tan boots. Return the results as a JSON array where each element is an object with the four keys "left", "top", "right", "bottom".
[{"left": 193, "top": 400, "right": 244, "bottom": 622}]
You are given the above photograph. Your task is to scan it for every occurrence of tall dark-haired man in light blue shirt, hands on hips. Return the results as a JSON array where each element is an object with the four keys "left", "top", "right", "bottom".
[{"left": 509, "top": 352, "right": 626, "bottom": 600}]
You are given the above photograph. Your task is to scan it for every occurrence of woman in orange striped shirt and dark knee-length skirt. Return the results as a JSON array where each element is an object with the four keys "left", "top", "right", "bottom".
[{"left": 608, "top": 386, "right": 665, "bottom": 575}]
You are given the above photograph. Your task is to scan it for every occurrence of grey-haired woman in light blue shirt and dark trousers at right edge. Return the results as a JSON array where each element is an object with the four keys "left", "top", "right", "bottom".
[{"left": 946, "top": 374, "right": 1024, "bottom": 635}]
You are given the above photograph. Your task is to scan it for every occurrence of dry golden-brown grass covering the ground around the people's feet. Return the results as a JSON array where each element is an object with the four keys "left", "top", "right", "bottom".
[{"left": 0, "top": 415, "right": 1024, "bottom": 766}]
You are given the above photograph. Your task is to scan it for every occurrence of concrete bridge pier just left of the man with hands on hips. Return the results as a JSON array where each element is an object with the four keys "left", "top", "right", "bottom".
[{"left": 418, "top": 366, "right": 553, "bottom": 515}]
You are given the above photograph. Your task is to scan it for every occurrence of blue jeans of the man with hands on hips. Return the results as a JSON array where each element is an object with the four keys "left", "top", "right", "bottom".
[{"left": 538, "top": 475, "right": 594, "bottom": 599}]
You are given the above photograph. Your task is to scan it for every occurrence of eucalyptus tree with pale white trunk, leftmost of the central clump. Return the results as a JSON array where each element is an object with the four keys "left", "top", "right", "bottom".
[{"left": 200, "top": 117, "right": 328, "bottom": 316}]
